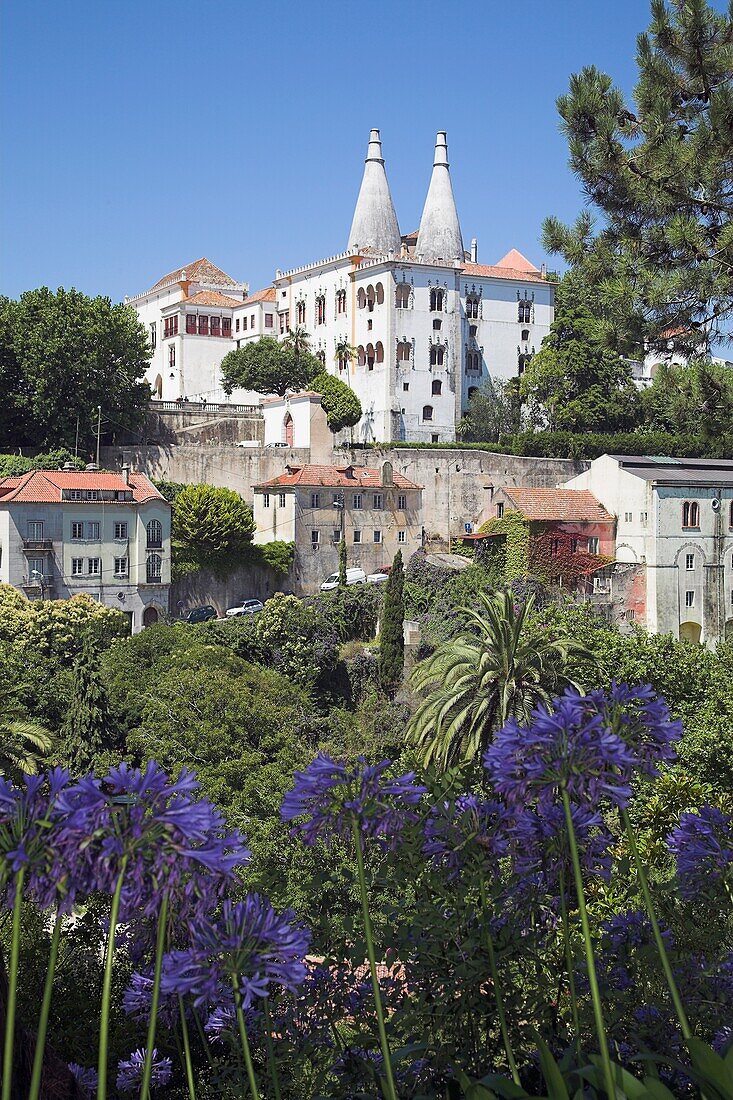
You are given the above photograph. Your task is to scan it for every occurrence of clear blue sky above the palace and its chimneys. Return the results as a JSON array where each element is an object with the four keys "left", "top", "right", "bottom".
[{"left": 0, "top": 0, "right": 669, "bottom": 299}]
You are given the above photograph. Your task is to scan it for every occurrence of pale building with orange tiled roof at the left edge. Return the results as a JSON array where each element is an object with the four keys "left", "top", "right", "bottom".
[{"left": 0, "top": 469, "right": 171, "bottom": 633}]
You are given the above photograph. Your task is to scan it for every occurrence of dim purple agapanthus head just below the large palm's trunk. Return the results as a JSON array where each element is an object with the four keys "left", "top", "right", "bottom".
[{"left": 423, "top": 794, "right": 510, "bottom": 876}]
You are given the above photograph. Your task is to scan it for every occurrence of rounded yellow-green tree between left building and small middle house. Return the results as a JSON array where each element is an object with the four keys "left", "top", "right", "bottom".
[{"left": 173, "top": 485, "right": 254, "bottom": 574}]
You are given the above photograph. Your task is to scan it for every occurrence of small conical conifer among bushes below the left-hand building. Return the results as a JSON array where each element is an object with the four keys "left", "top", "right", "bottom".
[{"left": 62, "top": 630, "right": 110, "bottom": 776}]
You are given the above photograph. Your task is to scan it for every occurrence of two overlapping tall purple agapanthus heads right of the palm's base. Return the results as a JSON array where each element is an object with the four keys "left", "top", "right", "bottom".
[{"left": 483, "top": 684, "right": 681, "bottom": 806}]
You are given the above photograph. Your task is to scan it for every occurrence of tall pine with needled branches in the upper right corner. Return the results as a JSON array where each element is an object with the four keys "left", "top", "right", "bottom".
[{"left": 544, "top": 0, "right": 733, "bottom": 354}]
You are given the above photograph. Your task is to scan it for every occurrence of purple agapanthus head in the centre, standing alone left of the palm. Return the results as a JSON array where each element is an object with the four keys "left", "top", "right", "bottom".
[{"left": 281, "top": 752, "right": 426, "bottom": 844}]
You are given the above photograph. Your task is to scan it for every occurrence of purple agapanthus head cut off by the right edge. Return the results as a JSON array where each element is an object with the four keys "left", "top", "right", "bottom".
[{"left": 667, "top": 806, "right": 733, "bottom": 899}]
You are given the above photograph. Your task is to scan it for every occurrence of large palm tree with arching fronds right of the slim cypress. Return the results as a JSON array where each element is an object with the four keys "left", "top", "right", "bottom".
[{"left": 407, "top": 591, "right": 595, "bottom": 769}]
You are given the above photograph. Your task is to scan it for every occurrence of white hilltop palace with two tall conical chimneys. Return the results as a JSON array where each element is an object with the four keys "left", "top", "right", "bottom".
[{"left": 127, "top": 130, "right": 555, "bottom": 442}]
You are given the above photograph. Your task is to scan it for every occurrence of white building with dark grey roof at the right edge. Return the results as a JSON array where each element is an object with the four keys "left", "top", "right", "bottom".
[{"left": 566, "top": 454, "right": 733, "bottom": 646}]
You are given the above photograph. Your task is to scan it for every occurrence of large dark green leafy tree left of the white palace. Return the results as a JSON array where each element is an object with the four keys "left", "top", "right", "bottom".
[{"left": 0, "top": 287, "right": 151, "bottom": 453}]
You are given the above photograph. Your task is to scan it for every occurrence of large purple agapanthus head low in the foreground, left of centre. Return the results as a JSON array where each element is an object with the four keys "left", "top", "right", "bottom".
[{"left": 161, "top": 894, "right": 310, "bottom": 1009}]
